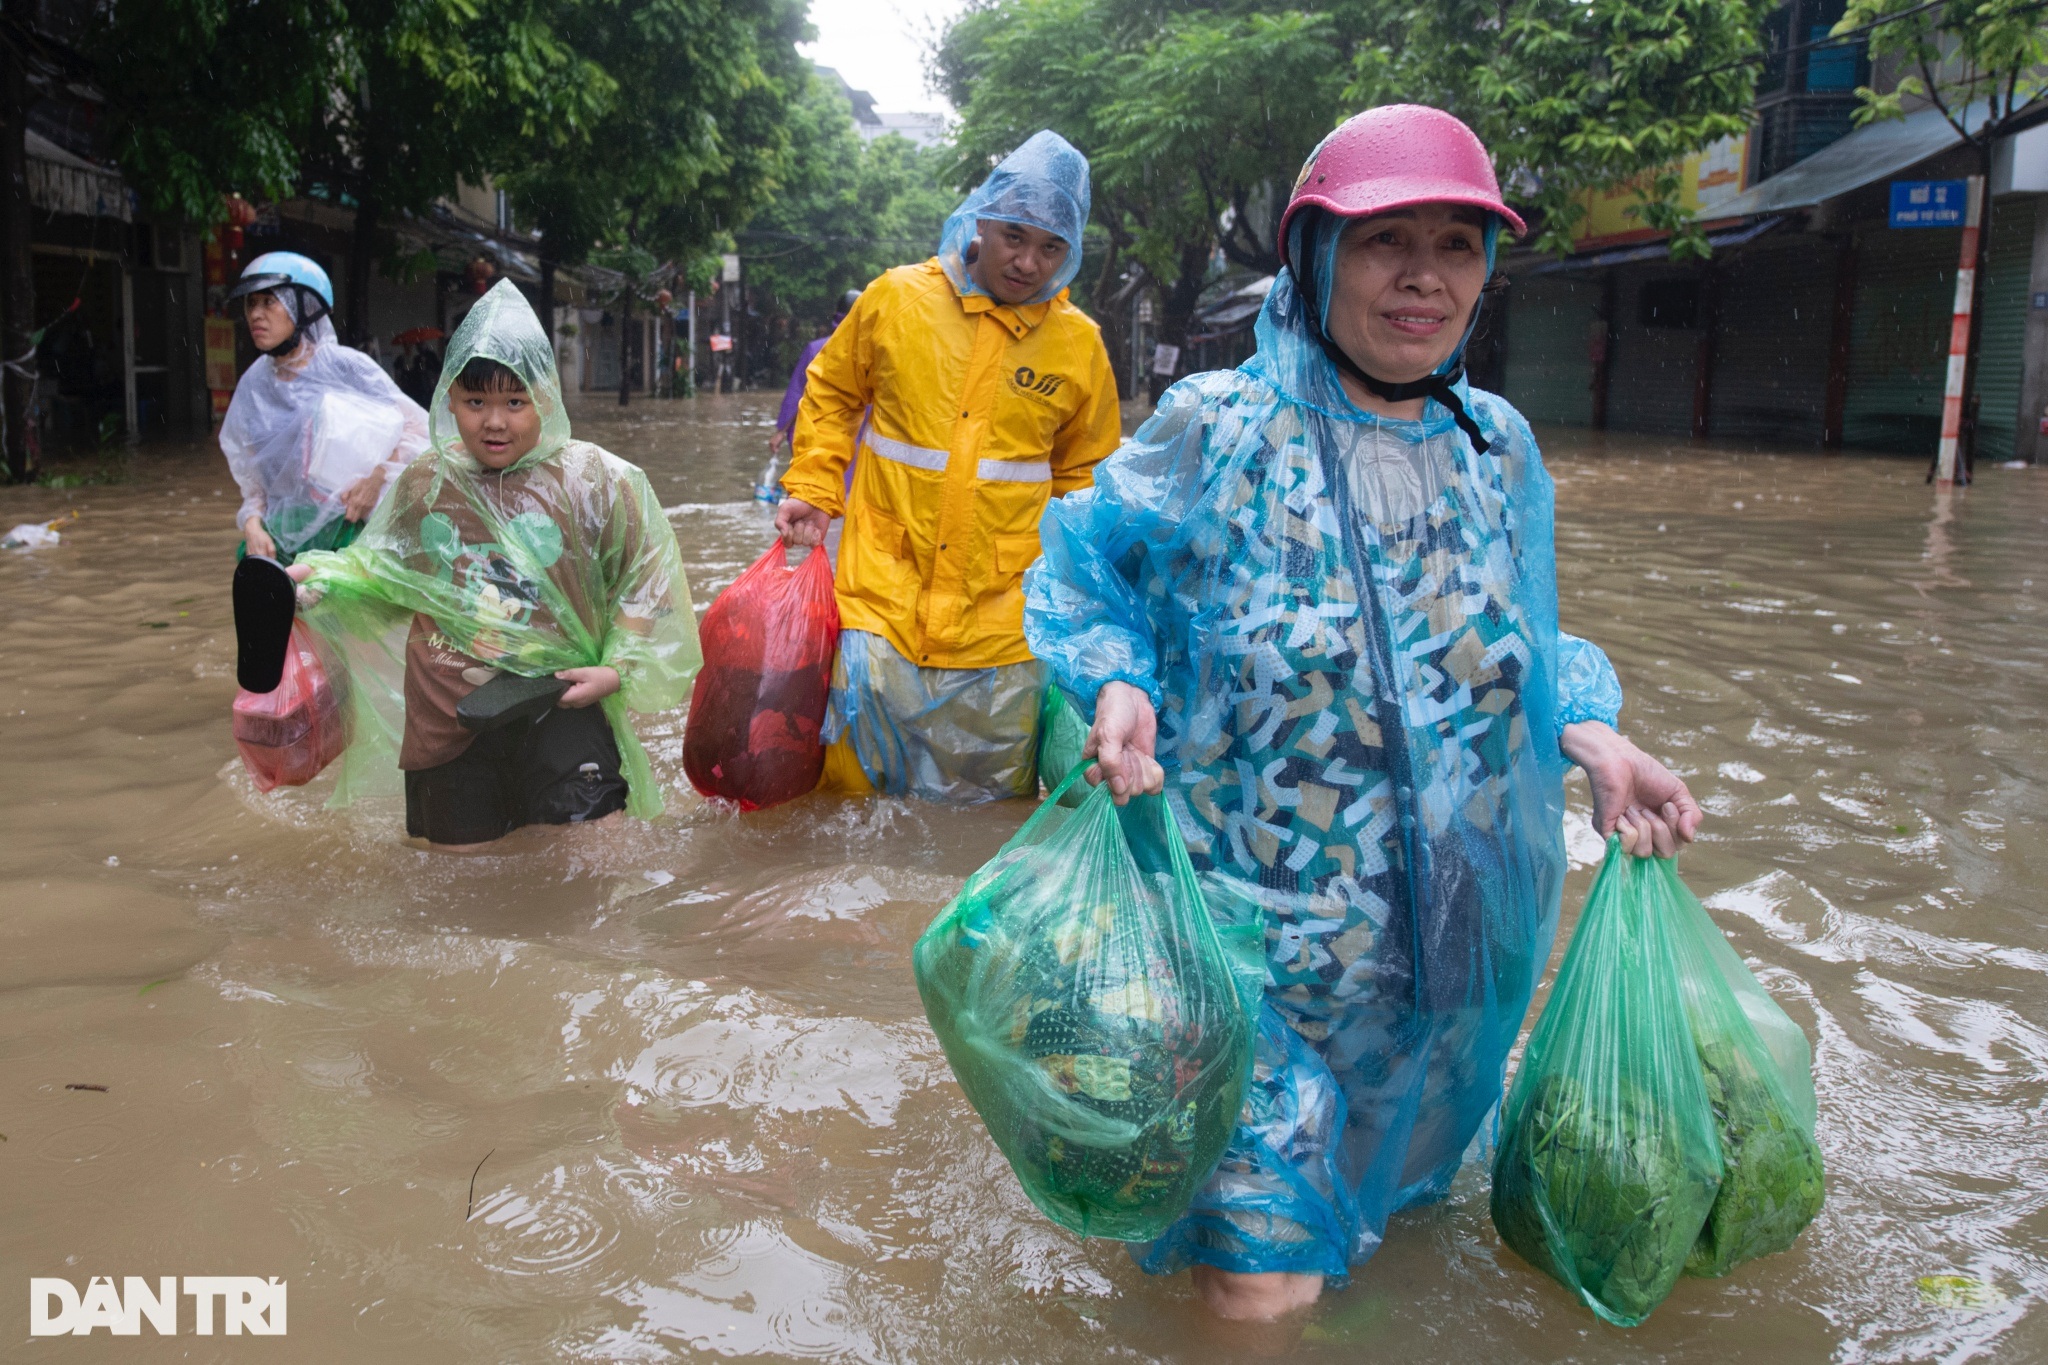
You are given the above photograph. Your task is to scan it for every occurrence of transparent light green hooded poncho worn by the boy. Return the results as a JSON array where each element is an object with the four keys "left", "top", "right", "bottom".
[{"left": 299, "top": 280, "right": 700, "bottom": 819}]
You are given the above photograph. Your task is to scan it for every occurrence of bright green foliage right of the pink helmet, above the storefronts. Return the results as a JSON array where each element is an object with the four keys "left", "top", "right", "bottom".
[{"left": 1348, "top": 0, "right": 1776, "bottom": 256}]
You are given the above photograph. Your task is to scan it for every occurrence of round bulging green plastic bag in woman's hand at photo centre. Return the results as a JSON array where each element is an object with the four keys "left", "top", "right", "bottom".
[{"left": 911, "top": 772, "right": 1264, "bottom": 1242}]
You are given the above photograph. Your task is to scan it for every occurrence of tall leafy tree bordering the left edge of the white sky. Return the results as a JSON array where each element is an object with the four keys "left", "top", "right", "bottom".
[{"left": 498, "top": 0, "right": 807, "bottom": 403}]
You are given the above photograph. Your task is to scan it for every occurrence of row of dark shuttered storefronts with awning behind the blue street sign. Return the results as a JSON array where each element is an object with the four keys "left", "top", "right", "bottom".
[{"left": 1497, "top": 101, "right": 2048, "bottom": 460}]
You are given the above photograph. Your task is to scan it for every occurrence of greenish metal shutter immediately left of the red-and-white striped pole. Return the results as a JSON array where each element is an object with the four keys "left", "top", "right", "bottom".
[{"left": 1841, "top": 225, "right": 1949, "bottom": 458}]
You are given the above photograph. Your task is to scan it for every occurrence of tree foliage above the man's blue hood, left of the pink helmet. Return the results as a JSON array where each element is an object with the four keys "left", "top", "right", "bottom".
[{"left": 938, "top": 0, "right": 1362, "bottom": 394}]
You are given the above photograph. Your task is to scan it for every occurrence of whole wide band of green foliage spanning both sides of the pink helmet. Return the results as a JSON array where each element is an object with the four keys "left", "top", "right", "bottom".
[{"left": 938, "top": 0, "right": 1774, "bottom": 340}]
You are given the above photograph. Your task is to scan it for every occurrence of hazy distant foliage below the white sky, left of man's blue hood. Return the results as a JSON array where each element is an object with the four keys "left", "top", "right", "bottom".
[{"left": 739, "top": 76, "right": 956, "bottom": 339}]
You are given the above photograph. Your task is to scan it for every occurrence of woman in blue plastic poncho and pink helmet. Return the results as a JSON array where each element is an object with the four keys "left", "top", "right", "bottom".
[{"left": 1026, "top": 104, "right": 1700, "bottom": 1320}]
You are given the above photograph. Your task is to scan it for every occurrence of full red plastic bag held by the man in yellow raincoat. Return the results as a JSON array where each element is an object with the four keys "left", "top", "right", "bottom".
[{"left": 682, "top": 540, "right": 840, "bottom": 810}]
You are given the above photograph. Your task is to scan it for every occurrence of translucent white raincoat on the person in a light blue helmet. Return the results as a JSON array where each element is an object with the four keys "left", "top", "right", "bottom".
[{"left": 221, "top": 313, "right": 426, "bottom": 557}]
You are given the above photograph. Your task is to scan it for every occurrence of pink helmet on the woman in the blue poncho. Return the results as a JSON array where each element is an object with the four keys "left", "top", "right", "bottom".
[{"left": 1280, "top": 104, "right": 1528, "bottom": 264}]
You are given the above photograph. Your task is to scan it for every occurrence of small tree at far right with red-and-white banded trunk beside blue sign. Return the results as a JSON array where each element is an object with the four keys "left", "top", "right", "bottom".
[{"left": 1835, "top": 0, "right": 2048, "bottom": 474}]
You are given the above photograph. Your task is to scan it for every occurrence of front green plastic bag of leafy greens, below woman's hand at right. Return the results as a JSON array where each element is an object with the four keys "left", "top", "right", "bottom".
[{"left": 1493, "top": 839, "right": 1722, "bottom": 1326}]
